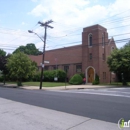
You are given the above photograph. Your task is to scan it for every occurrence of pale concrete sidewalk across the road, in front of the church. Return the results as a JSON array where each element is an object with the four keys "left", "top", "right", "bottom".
[{"left": 0, "top": 84, "right": 115, "bottom": 90}]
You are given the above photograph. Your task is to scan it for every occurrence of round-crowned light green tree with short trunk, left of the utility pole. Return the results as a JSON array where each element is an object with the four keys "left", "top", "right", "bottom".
[{"left": 6, "top": 52, "right": 36, "bottom": 86}]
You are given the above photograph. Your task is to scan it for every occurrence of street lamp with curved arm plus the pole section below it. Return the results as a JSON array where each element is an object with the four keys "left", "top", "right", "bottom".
[{"left": 28, "top": 30, "right": 45, "bottom": 89}]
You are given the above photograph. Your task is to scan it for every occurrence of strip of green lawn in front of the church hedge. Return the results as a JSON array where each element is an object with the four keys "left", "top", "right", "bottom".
[{"left": 22, "top": 82, "right": 69, "bottom": 87}]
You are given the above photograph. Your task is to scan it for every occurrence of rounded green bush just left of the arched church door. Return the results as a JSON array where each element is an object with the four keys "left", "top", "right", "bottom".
[{"left": 69, "top": 74, "right": 83, "bottom": 85}]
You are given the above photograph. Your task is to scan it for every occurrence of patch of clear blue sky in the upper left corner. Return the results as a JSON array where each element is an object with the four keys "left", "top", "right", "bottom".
[{"left": 0, "top": 0, "right": 37, "bottom": 30}]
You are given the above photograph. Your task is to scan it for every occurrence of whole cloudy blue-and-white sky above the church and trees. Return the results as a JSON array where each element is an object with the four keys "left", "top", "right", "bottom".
[{"left": 0, "top": 0, "right": 130, "bottom": 53}]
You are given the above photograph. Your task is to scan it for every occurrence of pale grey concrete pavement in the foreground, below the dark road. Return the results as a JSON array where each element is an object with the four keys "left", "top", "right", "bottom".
[{"left": 0, "top": 98, "right": 119, "bottom": 130}]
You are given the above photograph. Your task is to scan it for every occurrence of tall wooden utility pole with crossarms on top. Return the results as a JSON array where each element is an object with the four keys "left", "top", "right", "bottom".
[{"left": 38, "top": 20, "right": 53, "bottom": 89}]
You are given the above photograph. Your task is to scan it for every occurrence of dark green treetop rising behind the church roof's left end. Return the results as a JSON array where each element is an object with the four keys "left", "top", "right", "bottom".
[{"left": 13, "top": 43, "right": 42, "bottom": 55}]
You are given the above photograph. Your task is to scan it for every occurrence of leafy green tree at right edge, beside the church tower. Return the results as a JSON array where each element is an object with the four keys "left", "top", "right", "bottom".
[{"left": 107, "top": 43, "right": 130, "bottom": 84}]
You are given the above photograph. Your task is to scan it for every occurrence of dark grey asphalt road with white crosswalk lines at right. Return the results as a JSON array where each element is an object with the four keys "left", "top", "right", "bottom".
[{"left": 0, "top": 88, "right": 130, "bottom": 123}]
